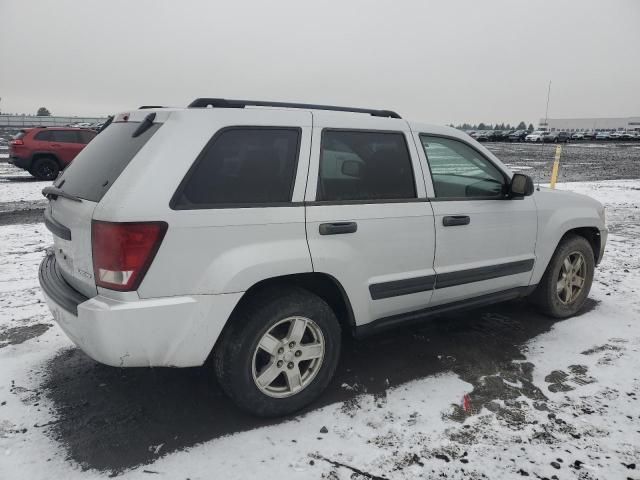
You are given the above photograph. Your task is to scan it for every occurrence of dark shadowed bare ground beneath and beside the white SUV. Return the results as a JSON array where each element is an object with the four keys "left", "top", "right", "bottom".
[{"left": 43, "top": 301, "right": 595, "bottom": 475}]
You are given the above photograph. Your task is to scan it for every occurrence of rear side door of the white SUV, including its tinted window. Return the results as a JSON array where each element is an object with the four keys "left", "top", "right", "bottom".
[{"left": 305, "top": 112, "right": 434, "bottom": 325}]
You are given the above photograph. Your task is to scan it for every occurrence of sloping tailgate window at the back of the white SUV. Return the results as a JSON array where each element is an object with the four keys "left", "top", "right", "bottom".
[{"left": 56, "top": 122, "right": 162, "bottom": 202}]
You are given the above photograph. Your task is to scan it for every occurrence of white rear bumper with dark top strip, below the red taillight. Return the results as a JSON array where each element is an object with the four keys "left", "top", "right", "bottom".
[{"left": 39, "top": 251, "right": 242, "bottom": 367}]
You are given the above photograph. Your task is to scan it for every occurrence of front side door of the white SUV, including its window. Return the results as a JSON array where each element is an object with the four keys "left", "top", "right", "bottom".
[{"left": 414, "top": 133, "right": 538, "bottom": 306}]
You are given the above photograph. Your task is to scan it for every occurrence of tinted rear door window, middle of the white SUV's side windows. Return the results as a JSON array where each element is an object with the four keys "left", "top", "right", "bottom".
[{"left": 316, "top": 130, "right": 416, "bottom": 200}]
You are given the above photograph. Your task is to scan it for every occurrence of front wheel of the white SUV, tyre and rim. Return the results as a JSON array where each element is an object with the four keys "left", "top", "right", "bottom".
[{"left": 530, "top": 234, "right": 595, "bottom": 318}]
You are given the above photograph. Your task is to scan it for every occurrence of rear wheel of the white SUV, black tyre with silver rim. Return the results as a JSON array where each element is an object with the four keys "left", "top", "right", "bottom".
[{"left": 214, "top": 287, "right": 341, "bottom": 417}]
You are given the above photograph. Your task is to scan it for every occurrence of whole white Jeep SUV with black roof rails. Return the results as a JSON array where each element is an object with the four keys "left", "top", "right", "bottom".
[{"left": 40, "top": 99, "right": 607, "bottom": 416}]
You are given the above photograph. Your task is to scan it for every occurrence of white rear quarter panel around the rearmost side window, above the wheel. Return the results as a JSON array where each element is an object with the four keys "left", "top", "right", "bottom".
[{"left": 94, "top": 109, "right": 312, "bottom": 298}]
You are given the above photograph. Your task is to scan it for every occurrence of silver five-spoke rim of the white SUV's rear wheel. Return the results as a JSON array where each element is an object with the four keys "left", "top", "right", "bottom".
[{"left": 251, "top": 317, "right": 325, "bottom": 398}]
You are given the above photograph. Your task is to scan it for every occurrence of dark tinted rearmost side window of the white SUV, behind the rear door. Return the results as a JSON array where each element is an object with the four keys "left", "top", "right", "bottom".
[{"left": 171, "top": 127, "right": 300, "bottom": 209}]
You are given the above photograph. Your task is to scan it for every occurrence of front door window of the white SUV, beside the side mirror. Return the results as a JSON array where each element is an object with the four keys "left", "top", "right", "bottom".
[{"left": 420, "top": 135, "right": 505, "bottom": 198}]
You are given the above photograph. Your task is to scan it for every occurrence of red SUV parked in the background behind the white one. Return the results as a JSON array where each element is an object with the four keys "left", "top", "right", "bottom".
[{"left": 9, "top": 127, "right": 97, "bottom": 180}]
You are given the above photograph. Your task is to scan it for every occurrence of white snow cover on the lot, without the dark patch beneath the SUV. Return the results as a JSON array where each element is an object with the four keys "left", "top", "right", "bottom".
[{"left": 0, "top": 180, "right": 640, "bottom": 480}]
